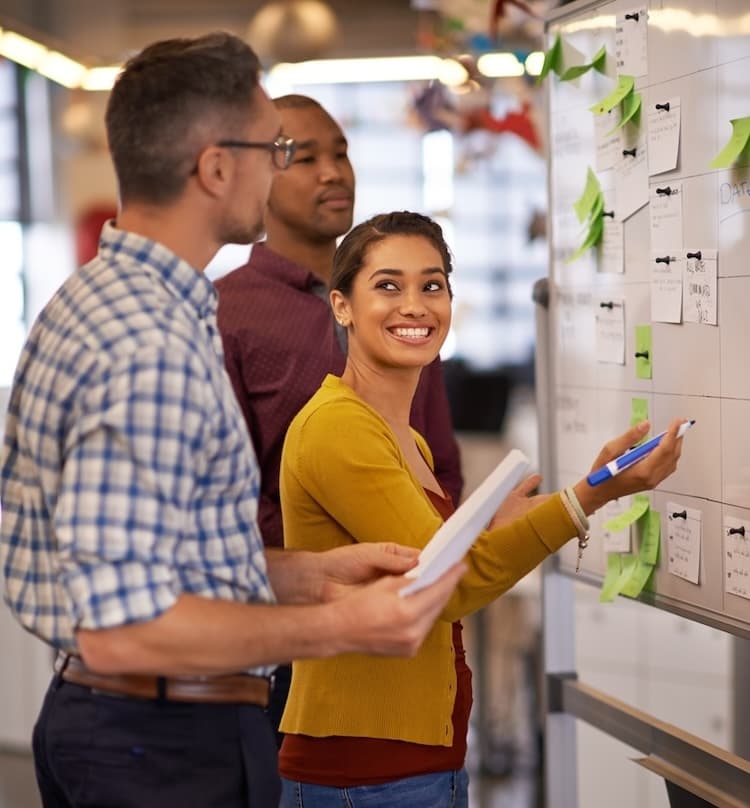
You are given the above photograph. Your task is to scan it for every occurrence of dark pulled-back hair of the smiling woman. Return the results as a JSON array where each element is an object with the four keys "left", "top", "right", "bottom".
[{"left": 329, "top": 210, "right": 453, "bottom": 297}]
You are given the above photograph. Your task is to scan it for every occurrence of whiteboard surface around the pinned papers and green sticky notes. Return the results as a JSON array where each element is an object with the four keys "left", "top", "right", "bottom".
[{"left": 545, "top": 0, "right": 750, "bottom": 636}]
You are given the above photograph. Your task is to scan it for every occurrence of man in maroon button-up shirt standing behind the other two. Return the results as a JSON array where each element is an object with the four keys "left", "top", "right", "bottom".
[{"left": 216, "top": 95, "right": 463, "bottom": 740}]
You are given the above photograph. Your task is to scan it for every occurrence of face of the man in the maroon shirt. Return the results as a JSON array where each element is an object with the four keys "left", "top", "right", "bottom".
[{"left": 266, "top": 106, "right": 354, "bottom": 243}]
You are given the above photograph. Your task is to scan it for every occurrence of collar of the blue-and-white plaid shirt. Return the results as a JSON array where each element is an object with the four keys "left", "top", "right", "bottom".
[{"left": 99, "top": 220, "right": 217, "bottom": 317}]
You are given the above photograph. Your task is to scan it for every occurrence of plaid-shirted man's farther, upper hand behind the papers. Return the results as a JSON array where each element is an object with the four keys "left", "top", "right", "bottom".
[{"left": 317, "top": 542, "right": 419, "bottom": 602}]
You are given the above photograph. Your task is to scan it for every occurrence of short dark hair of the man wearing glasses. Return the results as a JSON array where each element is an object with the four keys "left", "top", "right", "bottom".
[{"left": 106, "top": 32, "right": 260, "bottom": 204}]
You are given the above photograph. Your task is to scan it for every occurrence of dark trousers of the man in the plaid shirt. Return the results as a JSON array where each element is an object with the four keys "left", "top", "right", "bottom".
[{"left": 33, "top": 677, "right": 281, "bottom": 808}]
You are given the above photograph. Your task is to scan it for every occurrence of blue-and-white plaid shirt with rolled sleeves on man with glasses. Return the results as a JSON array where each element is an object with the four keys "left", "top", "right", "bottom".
[{"left": 0, "top": 224, "right": 274, "bottom": 664}]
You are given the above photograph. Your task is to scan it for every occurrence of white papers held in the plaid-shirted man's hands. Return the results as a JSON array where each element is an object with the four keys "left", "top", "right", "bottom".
[{"left": 401, "top": 449, "right": 530, "bottom": 595}]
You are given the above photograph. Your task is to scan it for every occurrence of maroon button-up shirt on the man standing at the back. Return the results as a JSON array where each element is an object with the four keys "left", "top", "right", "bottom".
[{"left": 216, "top": 244, "right": 463, "bottom": 547}]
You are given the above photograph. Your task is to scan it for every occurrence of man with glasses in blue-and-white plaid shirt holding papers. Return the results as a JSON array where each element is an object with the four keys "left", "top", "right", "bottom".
[{"left": 0, "top": 34, "right": 463, "bottom": 808}]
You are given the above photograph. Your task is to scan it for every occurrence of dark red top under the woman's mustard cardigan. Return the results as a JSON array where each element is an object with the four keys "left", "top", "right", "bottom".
[{"left": 279, "top": 489, "right": 472, "bottom": 788}]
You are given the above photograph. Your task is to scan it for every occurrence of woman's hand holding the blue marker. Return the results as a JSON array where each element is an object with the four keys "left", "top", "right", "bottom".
[{"left": 574, "top": 418, "right": 687, "bottom": 515}]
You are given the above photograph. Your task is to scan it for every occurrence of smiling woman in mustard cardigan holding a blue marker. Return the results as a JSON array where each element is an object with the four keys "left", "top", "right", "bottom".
[{"left": 280, "top": 212, "right": 679, "bottom": 808}]
